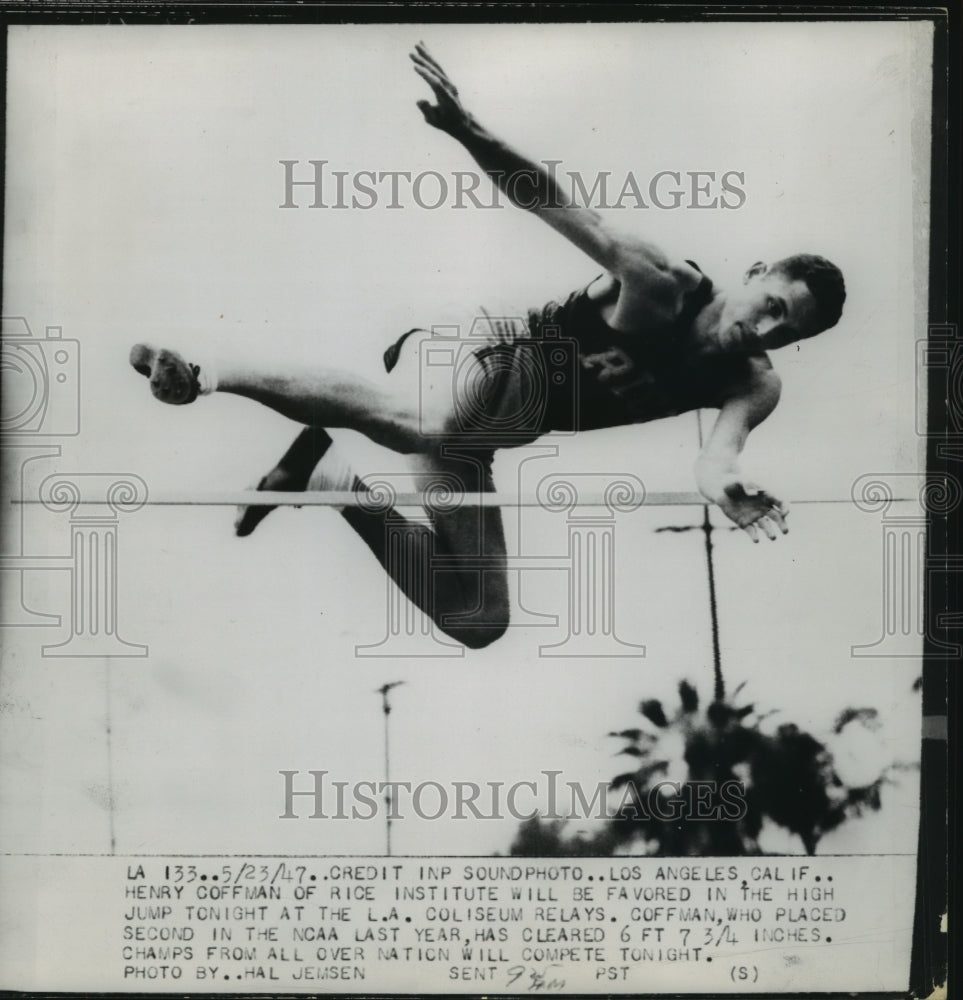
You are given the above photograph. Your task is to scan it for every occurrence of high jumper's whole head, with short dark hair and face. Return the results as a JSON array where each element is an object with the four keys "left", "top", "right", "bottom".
[{"left": 719, "top": 253, "right": 846, "bottom": 350}]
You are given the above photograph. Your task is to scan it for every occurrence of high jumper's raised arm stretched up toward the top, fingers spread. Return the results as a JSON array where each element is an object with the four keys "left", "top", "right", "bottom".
[{"left": 411, "top": 42, "right": 669, "bottom": 278}]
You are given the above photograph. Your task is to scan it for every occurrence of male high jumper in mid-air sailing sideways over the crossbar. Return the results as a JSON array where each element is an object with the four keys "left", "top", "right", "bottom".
[{"left": 130, "top": 44, "right": 846, "bottom": 648}]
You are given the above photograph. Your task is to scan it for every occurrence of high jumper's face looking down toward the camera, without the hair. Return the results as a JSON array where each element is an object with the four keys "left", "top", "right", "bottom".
[{"left": 716, "top": 264, "right": 819, "bottom": 353}]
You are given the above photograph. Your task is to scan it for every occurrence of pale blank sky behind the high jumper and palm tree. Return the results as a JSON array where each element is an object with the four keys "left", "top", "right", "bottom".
[{"left": 0, "top": 23, "right": 929, "bottom": 854}]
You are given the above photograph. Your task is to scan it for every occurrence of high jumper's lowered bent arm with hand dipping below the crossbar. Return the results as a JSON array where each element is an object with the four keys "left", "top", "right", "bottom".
[{"left": 696, "top": 369, "right": 789, "bottom": 542}]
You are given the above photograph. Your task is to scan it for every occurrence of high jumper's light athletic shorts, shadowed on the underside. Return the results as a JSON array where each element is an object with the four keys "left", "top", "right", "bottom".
[{"left": 384, "top": 309, "right": 578, "bottom": 448}]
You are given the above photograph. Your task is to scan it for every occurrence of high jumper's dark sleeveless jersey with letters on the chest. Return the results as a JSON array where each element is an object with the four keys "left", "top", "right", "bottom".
[{"left": 529, "top": 261, "right": 750, "bottom": 431}]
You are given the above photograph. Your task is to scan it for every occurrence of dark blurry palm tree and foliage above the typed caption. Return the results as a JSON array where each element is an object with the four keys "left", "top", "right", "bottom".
[{"left": 511, "top": 681, "right": 909, "bottom": 857}]
